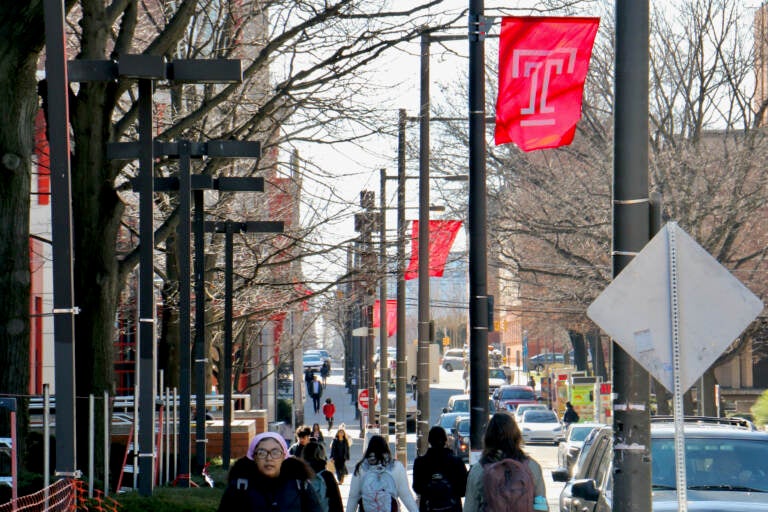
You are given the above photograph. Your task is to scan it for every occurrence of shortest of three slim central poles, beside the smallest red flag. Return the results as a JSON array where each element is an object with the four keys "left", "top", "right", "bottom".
[{"left": 379, "top": 169, "right": 389, "bottom": 439}]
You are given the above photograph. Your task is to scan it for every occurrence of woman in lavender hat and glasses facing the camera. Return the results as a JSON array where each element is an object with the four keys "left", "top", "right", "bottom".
[{"left": 218, "top": 432, "right": 323, "bottom": 512}]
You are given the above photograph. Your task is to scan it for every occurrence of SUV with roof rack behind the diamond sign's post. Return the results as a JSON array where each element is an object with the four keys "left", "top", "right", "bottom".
[{"left": 552, "top": 418, "right": 768, "bottom": 512}]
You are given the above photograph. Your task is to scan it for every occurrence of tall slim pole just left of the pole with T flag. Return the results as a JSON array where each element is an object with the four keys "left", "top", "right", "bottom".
[{"left": 416, "top": 33, "right": 429, "bottom": 455}]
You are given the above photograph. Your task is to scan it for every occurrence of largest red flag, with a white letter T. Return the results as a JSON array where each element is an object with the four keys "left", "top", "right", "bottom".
[{"left": 495, "top": 16, "right": 600, "bottom": 151}]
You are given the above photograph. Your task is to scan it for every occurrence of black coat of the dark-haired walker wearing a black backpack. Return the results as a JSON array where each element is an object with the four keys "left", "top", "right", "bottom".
[{"left": 413, "top": 448, "right": 467, "bottom": 512}]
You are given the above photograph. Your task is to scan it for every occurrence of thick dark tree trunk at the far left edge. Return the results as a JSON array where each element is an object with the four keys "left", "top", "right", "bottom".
[{"left": 0, "top": 2, "right": 43, "bottom": 469}]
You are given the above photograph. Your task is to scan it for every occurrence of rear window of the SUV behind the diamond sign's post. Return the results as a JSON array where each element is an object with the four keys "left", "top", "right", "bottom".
[{"left": 651, "top": 436, "right": 768, "bottom": 493}]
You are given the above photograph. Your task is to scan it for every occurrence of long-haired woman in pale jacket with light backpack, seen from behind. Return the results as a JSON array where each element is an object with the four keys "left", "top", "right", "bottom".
[{"left": 347, "top": 435, "right": 419, "bottom": 512}]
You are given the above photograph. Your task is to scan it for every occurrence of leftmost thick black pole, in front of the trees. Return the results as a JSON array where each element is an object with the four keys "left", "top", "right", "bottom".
[{"left": 43, "top": 0, "right": 79, "bottom": 478}]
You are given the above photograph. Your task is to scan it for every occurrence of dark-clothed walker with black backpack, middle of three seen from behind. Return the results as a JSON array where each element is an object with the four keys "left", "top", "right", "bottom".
[{"left": 413, "top": 425, "right": 467, "bottom": 512}]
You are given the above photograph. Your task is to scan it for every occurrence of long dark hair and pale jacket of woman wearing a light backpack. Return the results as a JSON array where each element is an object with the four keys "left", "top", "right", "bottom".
[{"left": 347, "top": 435, "right": 419, "bottom": 512}]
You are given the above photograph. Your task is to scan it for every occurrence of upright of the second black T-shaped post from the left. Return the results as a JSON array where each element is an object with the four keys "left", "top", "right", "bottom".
[{"left": 176, "top": 140, "right": 192, "bottom": 487}]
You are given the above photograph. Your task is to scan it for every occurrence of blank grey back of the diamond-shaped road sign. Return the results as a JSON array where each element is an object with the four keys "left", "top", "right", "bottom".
[{"left": 587, "top": 222, "right": 763, "bottom": 391}]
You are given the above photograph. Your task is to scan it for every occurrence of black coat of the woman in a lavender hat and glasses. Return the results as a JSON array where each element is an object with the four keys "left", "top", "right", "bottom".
[{"left": 218, "top": 457, "right": 322, "bottom": 512}]
